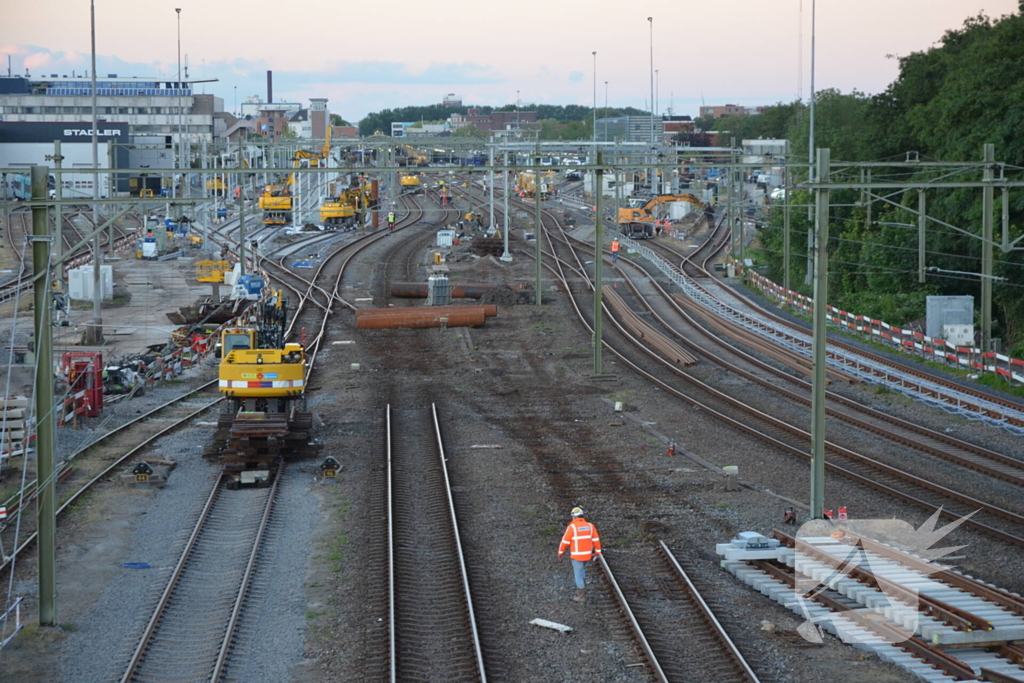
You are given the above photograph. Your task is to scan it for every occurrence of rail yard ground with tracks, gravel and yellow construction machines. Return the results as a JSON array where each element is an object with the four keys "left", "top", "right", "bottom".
[{"left": 0, "top": 149, "right": 1024, "bottom": 683}]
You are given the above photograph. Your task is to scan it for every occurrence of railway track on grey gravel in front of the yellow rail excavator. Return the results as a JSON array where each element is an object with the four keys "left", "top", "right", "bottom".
[{"left": 121, "top": 472, "right": 283, "bottom": 683}]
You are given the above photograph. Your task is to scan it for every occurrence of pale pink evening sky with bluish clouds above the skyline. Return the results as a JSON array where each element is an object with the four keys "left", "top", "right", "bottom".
[{"left": 0, "top": 0, "right": 1018, "bottom": 120}]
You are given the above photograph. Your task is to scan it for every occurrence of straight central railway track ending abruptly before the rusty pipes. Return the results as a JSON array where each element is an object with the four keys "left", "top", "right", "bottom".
[{"left": 385, "top": 404, "right": 486, "bottom": 683}]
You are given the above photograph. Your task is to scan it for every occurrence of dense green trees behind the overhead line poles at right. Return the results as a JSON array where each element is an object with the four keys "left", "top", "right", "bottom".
[{"left": 696, "top": 14, "right": 1024, "bottom": 357}]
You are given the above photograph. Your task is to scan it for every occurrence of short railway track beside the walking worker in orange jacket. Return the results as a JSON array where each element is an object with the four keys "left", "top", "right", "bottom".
[{"left": 597, "top": 541, "right": 760, "bottom": 683}]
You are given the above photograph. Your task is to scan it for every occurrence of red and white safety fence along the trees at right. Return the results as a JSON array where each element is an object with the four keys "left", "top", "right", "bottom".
[{"left": 731, "top": 260, "right": 1024, "bottom": 386}]
